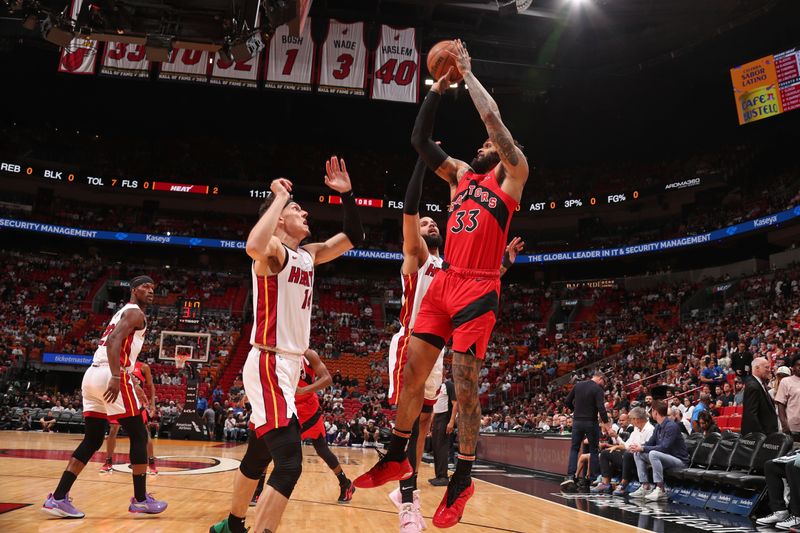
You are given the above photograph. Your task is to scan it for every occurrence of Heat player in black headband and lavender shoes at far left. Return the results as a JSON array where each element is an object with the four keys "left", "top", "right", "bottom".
[{"left": 42, "top": 276, "right": 167, "bottom": 518}]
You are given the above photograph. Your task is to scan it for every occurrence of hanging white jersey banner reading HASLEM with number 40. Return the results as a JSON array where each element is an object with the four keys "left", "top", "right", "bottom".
[{"left": 372, "top": 25, "right": 420, "bottom": 104}]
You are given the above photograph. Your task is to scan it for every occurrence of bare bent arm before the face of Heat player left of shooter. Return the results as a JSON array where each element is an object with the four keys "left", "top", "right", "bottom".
[{"left": 245, "top": 178, "right": 292, "bottom": 272}]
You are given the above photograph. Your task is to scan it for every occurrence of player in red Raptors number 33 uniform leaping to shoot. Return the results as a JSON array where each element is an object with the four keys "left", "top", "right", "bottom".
[{"left": 354, "top": 40, "right": 528, "bottom": 528}]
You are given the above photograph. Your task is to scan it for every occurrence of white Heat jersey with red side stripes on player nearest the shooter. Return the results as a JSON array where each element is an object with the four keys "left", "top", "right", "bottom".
[{"left": 250, "top": 246, "right": 314, "bottom": 356}]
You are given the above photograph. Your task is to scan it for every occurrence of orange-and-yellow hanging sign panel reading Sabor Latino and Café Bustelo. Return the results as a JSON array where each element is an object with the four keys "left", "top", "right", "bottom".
[{"left": 731, "top": 56, "right": 781, "bottom": 125}]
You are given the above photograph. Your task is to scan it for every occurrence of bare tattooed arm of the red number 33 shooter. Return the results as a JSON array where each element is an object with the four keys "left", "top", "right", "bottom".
[{"left": 455, "top": 39, "right": 528, "bottom": 200}]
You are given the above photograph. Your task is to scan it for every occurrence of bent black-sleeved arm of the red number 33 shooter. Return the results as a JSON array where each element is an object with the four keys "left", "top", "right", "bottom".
[{"left": 411, "top": 69, "right": 469, "bottom": 192}]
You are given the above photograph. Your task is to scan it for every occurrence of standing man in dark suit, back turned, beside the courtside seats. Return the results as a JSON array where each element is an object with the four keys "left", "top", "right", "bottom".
[{"left": 561, "top": 372, "right": 611, "bottom": 492}]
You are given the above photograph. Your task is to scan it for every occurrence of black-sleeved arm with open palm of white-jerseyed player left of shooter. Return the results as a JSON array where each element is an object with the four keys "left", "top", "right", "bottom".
[{"left": 304, "top": 156, "right": 364, "bottom": 265}]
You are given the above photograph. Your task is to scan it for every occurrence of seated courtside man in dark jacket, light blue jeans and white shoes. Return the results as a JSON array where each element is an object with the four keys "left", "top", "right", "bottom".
[{"left": 628, "top": 400, "right": 689, "bottom": 501}]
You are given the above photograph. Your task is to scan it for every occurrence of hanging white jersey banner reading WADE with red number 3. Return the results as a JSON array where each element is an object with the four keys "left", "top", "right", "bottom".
[{"left": 317, "top": 20, "right": 368, "bottom": 96}]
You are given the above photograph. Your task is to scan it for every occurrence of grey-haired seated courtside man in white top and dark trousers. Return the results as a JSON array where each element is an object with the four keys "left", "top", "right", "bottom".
[{"left": 591, "top": 407, "right": 653, "bottom": 496}]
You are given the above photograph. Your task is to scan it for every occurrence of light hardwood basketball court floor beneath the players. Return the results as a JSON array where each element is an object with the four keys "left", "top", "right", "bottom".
[{"left": 0, "top": 431, "right": 635, "bottom": 533}]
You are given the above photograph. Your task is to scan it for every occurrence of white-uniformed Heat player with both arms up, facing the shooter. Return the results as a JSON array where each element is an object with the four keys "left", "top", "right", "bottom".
[{"left": 210, "top": 156, "right": 364, "bottom": 533}]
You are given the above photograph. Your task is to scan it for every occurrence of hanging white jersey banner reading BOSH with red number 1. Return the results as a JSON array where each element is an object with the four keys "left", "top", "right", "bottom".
[{"left": 264, "top": 19, "right": 314, "bottom": 92}]
